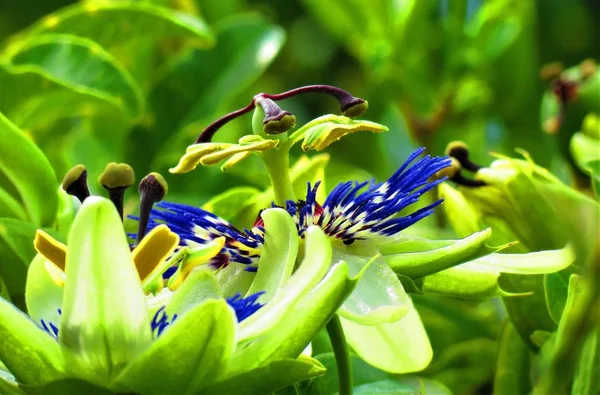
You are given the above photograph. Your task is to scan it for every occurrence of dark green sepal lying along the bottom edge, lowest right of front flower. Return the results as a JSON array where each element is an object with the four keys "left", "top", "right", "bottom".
[{"left": 205, "top": 356, "right": 325, "bottom": 395}]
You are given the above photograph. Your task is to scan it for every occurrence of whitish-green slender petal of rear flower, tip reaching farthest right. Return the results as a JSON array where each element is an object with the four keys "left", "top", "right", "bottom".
[{"left": 461, "top": 244, "right": 575, "bottom": 274}]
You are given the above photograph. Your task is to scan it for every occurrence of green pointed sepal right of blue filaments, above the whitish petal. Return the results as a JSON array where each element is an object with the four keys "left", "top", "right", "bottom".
[{"left": 382, "top": 229, "right": 496, "bottom": 278}]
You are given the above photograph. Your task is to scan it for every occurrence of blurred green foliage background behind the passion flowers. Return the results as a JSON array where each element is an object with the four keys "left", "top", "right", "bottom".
[{"left": 0, "top": 0, "right": 600, "bottom": 394}]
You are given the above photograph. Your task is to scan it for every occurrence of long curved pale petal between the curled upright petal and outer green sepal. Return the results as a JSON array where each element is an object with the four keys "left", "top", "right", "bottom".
[{"left": 238, "top": 226, "right": 331, "bottom": 342}]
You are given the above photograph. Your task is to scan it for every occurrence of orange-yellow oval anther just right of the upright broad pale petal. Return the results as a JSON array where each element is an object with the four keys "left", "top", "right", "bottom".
[{"left": 133, "top": 225, "right": 179, "bottom": 281}]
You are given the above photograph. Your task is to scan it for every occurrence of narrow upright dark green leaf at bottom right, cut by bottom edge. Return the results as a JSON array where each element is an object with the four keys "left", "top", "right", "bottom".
[{"left": 494, "top": 321, "right": 531, "bottom": 395}]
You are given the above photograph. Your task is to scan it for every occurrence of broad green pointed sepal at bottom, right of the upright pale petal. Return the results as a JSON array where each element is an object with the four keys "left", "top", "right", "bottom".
[{"left": 117, "top": 299, "right": 237, "bottom": 395}]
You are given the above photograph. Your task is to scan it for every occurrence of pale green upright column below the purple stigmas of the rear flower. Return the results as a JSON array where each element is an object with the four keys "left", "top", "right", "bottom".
[{"left": 252, "top": 106, "right": 296, "bottom": 207}]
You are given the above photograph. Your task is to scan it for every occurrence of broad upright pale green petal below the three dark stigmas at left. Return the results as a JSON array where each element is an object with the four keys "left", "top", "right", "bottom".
[{"left": 59, "top": 197, "right": 152, "bottom": 383}]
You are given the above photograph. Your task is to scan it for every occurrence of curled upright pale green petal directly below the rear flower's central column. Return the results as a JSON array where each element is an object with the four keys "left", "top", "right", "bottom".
[{"left": 247, "top": 208, "right": 300, "bottom": 303}]
